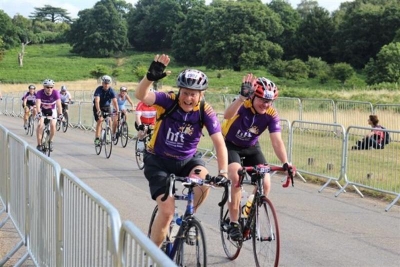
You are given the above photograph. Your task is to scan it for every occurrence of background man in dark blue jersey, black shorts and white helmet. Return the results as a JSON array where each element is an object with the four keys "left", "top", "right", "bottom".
[{"left": 93, "top": 75, "right": 119, "bottom": 146}]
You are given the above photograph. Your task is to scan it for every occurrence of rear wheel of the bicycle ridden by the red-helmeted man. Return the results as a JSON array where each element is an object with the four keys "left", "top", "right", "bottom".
[{"left": 219, "top": 194, "right": 243, "bottom": 260}]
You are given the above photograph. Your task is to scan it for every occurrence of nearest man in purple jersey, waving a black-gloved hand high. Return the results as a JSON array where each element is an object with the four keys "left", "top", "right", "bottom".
[{"left": 136, "top": 55, "right": 228, "bottom": 249}]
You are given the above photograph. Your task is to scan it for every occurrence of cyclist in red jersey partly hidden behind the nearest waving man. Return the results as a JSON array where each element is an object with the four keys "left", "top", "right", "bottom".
[{"left": 135, "top": 89, "right": 157, "bottom": 151}]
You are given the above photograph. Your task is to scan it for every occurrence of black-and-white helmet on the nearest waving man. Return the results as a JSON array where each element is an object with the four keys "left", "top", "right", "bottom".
[{"left": 176, "top": 69, "right": 208, "bottom": 91}]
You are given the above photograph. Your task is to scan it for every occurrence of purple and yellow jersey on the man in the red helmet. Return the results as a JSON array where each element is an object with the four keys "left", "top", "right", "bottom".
[{"left": 222, "top": 100, "right": 281, "bottom": 147}]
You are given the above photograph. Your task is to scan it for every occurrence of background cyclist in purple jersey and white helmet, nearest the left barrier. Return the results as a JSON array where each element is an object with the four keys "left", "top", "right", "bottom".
[{"left": 36, "top": 79, "right": 62, "bottom": 151}]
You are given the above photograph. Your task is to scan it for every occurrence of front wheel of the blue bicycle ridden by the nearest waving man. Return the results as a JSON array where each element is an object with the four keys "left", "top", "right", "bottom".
[{"left": 175, "top": 219, "right": 207, "bottom": 266}]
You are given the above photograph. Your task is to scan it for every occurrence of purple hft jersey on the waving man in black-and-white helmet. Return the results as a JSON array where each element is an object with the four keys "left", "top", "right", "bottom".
[{"left": 148, "top": 92, "right": 221, "bottom": 160}]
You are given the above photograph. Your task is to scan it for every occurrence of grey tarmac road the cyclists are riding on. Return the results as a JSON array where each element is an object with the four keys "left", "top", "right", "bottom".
[{"left": 0, "top": 115, "right": 400, "bottom": 267}]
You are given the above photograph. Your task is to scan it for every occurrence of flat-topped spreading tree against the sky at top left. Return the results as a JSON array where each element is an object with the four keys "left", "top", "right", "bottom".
[{"left": 29, "top": 5, "right": 72, "bottom": 23}]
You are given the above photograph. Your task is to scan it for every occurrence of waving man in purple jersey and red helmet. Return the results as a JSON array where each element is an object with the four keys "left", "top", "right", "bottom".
[{"left": 222, "top": 74, "right": 292, "bottom": 241}]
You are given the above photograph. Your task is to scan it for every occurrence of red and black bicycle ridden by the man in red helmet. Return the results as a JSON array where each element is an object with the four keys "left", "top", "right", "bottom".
[{"left": 219, "top": 164, "right": 295, "bottom": 266}]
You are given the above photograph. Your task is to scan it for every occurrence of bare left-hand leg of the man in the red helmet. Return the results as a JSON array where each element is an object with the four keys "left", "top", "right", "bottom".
[{"left": 228, "top": 162, "right": 242, "bottom": 222}]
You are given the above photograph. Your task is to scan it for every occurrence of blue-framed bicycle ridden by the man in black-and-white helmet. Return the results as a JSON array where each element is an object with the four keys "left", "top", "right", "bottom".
[{"left": 148, "top": 170, "right": 231, "bottom": 266}]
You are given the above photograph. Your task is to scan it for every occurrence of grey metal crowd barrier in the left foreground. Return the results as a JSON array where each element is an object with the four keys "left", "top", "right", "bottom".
[{"left": 0, "top": 125, "right": 175, "bottom": 267}]
